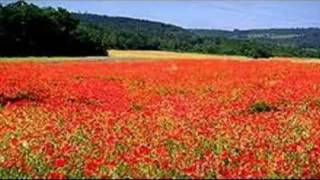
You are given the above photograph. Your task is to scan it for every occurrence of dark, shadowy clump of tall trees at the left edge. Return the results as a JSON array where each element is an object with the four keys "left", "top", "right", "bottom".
[{"left": 0, "top": 1, "right": 106, "bottom": 56}]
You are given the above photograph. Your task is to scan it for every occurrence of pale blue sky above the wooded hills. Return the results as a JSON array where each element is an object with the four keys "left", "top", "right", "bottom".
[{"left": 0, "top": 0, "right": 320, "bottom": 30}]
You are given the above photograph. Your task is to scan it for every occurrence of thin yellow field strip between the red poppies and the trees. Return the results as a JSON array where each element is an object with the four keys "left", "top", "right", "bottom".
[{"left": 0, "top": 50, "right": 320, "bottom": 63}]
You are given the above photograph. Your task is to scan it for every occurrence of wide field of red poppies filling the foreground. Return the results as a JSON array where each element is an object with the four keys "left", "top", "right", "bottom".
[{"left": 0, "top": 60, "right": 320, "bottom": 178}]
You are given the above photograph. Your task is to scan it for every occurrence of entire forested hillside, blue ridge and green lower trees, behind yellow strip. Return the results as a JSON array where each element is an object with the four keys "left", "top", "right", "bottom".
[{"left": 73, "top": 13, "right": 320, "bottom": 57}]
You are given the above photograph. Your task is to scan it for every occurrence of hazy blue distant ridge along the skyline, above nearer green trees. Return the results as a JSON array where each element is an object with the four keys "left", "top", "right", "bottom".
[{"left": 73, "top": 13, "right": 320, "bottom": 48}]
